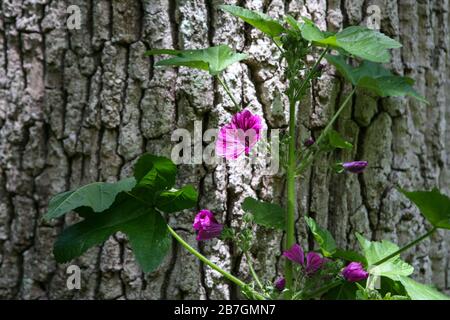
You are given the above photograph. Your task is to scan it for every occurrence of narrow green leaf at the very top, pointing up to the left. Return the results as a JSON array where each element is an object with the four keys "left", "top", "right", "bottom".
[{"left": 219, "top": 5, "right": 285, "bottom": 38}]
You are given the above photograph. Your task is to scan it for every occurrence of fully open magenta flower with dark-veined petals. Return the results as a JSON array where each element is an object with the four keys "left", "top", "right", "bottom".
[{"left": 216, "top": 110, "right": 262, "bottom": 159}]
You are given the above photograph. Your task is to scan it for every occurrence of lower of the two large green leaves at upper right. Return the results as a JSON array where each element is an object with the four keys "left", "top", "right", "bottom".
[{"left": 326, "top": 55, "right": 428, "bottom": 103}]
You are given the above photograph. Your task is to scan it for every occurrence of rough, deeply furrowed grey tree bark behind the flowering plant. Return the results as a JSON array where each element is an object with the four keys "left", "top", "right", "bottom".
[{"left": 0, "top": 0, "right": 450, "bottom": 299}]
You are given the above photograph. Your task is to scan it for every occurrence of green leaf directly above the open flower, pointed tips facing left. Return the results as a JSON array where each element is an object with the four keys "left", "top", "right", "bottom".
[{"left": 146, "top": 45, "right": 248, "bottom": 75}]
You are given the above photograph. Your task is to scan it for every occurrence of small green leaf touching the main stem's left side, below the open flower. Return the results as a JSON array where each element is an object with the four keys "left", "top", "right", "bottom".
[{"left": 242, "top": 197, "right": 285, "bottom": 230}]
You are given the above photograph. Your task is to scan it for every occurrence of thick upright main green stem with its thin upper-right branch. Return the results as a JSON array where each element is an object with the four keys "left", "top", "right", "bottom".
[{"left": 284, "top": 48, "right": 328, "bottom": 288}]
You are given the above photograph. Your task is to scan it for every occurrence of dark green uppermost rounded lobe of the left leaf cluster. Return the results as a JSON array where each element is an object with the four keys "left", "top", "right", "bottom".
[{"left": 134, "top": 153, "right": 177, "bottom": 191}]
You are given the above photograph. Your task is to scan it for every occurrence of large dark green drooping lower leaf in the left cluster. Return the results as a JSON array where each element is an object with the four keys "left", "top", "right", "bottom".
[{"left": 53, "top": 195, "right": 170, "bottom": 272}]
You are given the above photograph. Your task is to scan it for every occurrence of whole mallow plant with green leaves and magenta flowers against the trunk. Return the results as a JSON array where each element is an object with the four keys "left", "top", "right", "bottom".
[{"left": 45, "top": 5, "right": 450, "bottom": 299}]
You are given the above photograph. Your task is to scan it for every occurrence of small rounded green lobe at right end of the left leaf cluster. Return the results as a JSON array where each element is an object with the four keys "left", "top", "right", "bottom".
[{"left": 156, "top": 186, "right": 198, "bottom": 213}]
